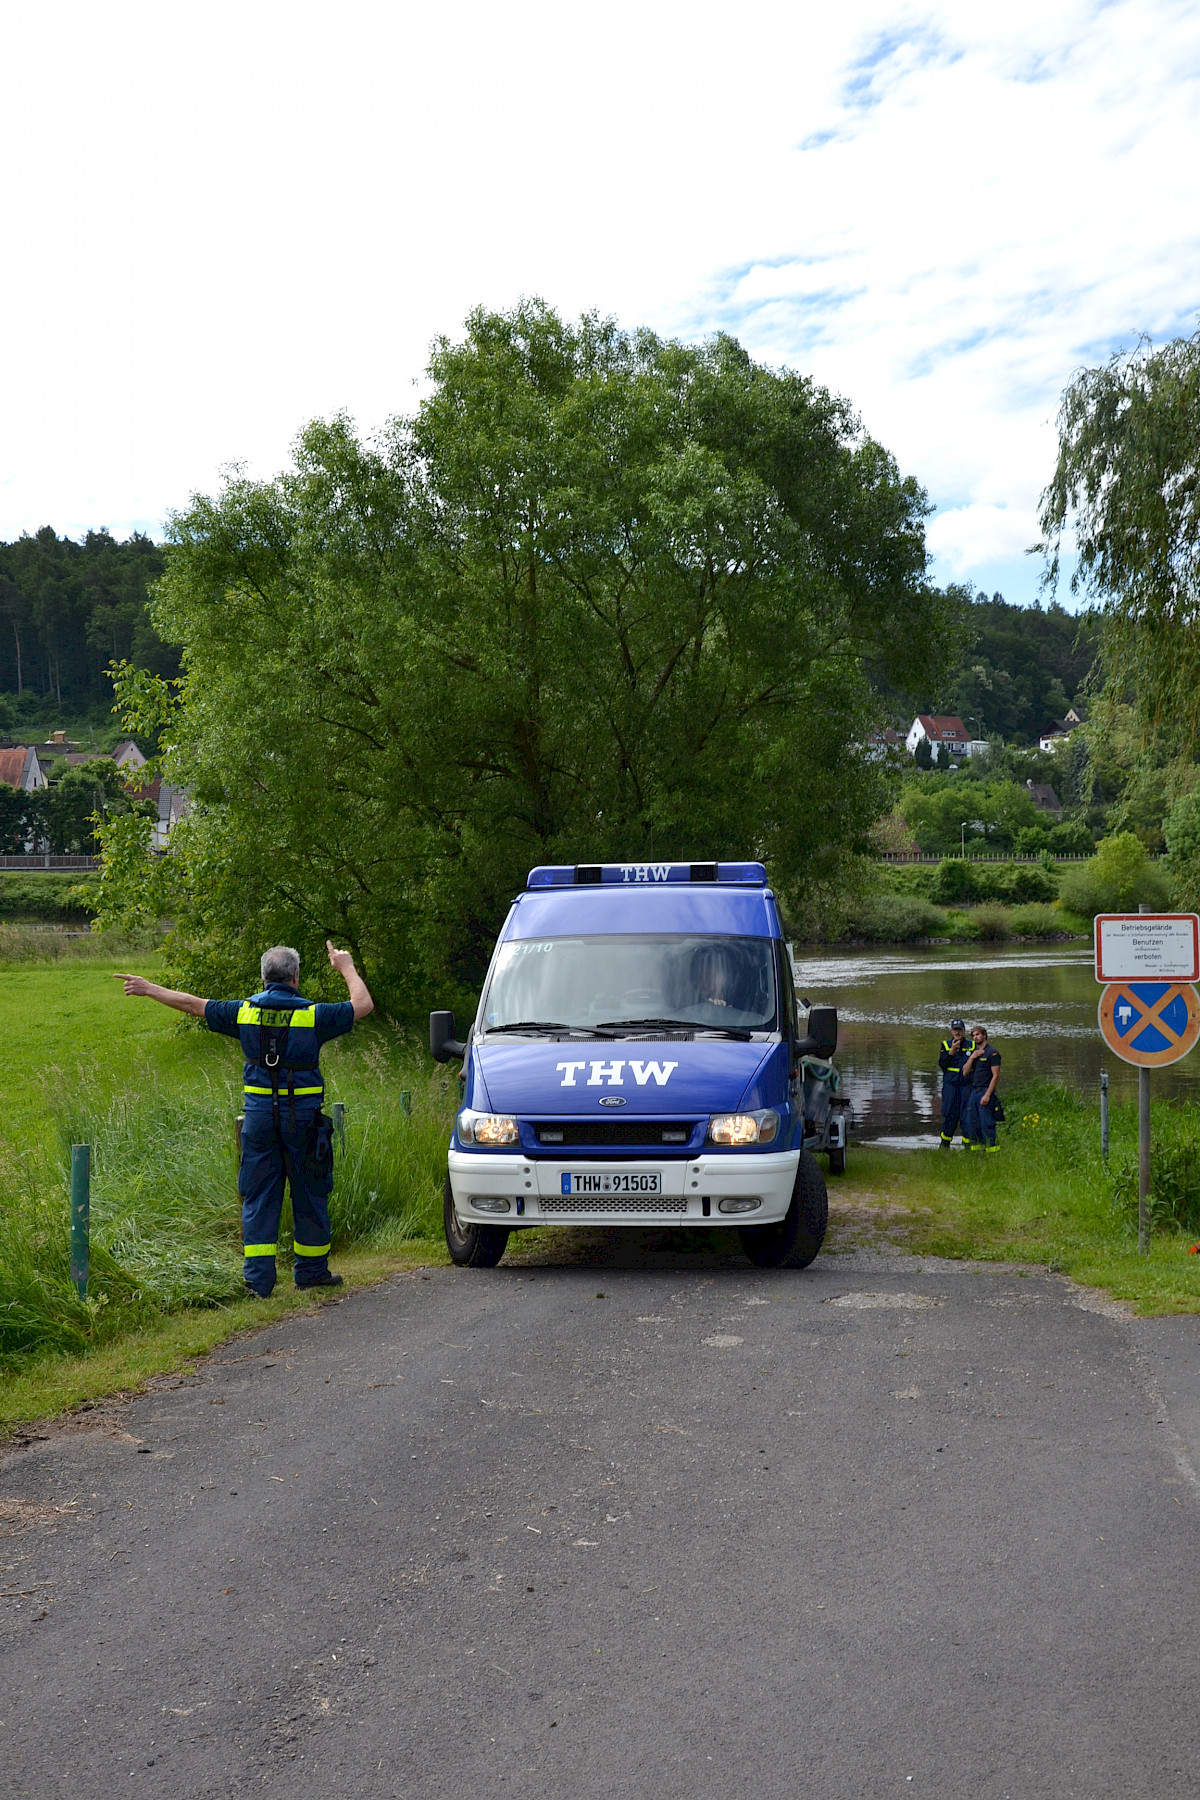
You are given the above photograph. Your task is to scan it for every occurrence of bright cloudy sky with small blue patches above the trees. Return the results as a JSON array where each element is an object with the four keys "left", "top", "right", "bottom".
[{"left": 0, "top": 0, "right": 1200, "bottom": 599}]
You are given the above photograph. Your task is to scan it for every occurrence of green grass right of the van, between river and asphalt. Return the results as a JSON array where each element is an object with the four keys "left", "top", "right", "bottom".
[{"left": 829, "top": 1085, "right": 1200, "bottom": 1314}]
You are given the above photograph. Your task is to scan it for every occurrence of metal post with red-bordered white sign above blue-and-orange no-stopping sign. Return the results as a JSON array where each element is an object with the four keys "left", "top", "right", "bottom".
[{"left": 1096, "top": 905, "right": 1200, "bottom": 1255}]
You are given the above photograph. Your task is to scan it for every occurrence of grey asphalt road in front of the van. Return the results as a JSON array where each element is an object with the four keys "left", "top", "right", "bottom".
[{"left": 0, "top": 1237, "right": 1200, "bottom": 1800}]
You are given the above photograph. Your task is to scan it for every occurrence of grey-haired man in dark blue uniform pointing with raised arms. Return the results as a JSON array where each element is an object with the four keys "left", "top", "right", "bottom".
[{"left": 117, "top": 943, "right": 374, "bottom": 1298}]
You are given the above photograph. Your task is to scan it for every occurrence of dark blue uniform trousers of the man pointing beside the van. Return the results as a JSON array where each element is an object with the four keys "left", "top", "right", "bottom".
[{"left": 237, "top": 1089, "right": 331, "bottom": 1296}]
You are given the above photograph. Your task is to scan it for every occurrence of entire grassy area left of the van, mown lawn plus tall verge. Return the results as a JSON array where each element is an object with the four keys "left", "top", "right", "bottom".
[{"left": 0, "top": 940, "right": 453, "bottom": 1418}]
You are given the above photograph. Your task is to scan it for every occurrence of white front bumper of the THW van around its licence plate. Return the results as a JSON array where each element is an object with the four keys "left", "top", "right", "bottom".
[{"left": 450, "top": 1150, "right": 801, "bottom": 1226}]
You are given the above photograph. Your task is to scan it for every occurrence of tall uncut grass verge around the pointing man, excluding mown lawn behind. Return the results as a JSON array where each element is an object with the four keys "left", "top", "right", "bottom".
[{"left": 0, "top": 1026, "right": 453, "bottom": 1368}]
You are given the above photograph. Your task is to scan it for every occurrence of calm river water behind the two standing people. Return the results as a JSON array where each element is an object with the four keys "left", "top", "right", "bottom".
[{"left": 795, "top": 941, "right": 1200, "bottom": 1148}]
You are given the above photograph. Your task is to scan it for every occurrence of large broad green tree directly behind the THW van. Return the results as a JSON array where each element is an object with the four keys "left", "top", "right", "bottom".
[{"left": 115, "top": 302, "right": 945, "bottom": 1008}]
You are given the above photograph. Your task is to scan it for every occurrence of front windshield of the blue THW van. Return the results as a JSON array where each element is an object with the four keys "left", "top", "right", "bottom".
[{"left": 484, "top": 932, "right": 777, "bottom": 1031}]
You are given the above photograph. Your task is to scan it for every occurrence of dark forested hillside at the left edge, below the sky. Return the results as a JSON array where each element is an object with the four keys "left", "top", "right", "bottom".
[{"left": 0, "top": 526, "right": 178, "bottom": 702}]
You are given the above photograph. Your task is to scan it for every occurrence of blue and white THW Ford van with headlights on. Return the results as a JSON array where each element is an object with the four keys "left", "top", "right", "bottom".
[{"left": 430, "top": 862, "right": 837, "bottom": 1269}]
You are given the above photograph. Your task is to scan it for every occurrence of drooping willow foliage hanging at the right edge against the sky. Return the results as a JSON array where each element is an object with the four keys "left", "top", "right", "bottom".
[{"left": 1042, "top": 333, "right": 1200, "bottom": 758}]
